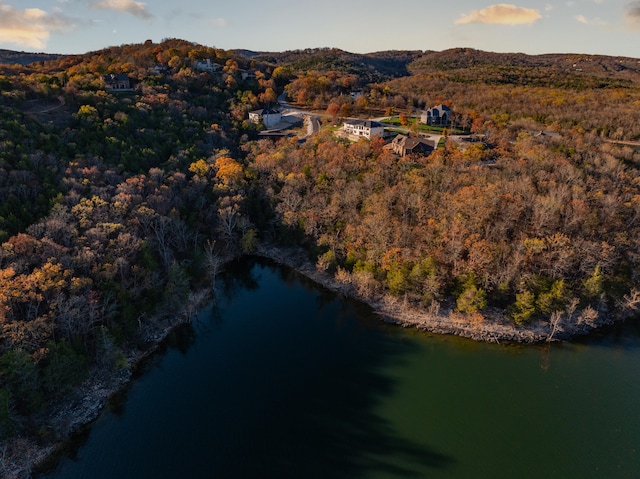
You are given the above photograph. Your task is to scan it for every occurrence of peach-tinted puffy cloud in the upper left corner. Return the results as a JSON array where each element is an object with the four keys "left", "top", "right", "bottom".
[{"left": 0, "top": 0, "right": 74, "bottom": 48}]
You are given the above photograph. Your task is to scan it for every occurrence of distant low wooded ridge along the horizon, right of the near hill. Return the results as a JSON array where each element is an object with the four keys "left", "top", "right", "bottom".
[{"left": 236, "top": 48, "right": 640, "bottom": 88}]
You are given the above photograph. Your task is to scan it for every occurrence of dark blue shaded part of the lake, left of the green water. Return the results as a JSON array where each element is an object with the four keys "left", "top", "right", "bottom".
[{"left": 40, "top": 260, "right": 453, "bottom": 479}]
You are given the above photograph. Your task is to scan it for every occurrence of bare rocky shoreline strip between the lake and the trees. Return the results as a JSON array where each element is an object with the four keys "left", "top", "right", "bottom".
[{"left": 0, "top": 245, "right": 635, "bottom": 479}]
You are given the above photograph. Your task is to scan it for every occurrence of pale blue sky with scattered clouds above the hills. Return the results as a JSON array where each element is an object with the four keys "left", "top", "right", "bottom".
[{"left": 0, "top": 0, "right": 640, "bottom": 58}]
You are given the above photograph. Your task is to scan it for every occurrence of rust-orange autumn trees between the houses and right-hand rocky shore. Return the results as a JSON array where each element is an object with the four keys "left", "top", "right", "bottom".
[{"left": 244, "top": 124, "right": 639, "bottom": 330}]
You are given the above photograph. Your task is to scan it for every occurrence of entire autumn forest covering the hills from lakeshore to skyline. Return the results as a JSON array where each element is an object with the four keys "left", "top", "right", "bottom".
[{"left": 0, "top": 39, "right": 640, "bottom": 474}]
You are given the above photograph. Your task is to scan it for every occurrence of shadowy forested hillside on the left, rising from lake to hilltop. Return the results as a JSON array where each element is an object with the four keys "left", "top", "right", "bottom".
[{"left": 0, "top": 40, "right": 273, "bottom": 466}]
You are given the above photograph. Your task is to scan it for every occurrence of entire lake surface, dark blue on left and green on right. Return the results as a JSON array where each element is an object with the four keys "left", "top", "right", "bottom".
[{"left": 40, "top": 260, "right": 640, "bottom": 479}]
